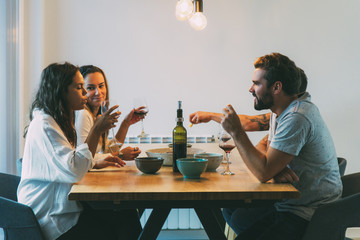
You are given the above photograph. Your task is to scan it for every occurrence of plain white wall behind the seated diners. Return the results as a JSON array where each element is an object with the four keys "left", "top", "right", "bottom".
[{"left": 24, "top": 0, "right": 360, "bottom": 173}]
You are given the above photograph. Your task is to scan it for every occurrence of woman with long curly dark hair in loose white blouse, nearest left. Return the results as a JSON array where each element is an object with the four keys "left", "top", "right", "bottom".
[{"left": 18, "top": 63, "right": 124, "bottom": 239}]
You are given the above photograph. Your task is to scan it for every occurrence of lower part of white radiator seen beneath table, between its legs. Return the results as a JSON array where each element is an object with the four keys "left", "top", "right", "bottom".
[{"left": 140, "top": 208, "right": 203, "bottom": 229}]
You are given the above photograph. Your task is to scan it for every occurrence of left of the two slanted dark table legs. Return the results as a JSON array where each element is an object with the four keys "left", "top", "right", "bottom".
[{"left": 138, "top": 208, "right": 171, "bottom": 240}]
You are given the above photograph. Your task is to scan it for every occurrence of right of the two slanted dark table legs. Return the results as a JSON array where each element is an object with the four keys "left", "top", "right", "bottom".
[{"left": 195, "top": 208, "right": 226, "bottom": 240}]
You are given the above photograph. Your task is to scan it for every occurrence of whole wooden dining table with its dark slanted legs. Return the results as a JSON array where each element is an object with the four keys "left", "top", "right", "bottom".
[{"left": 68, "top": 143, "right": 300, "bottom": 240}]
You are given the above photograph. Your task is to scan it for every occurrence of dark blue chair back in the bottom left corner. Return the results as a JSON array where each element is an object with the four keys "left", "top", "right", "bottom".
[{"left": 0, "top": 197, "right": 44, "bottom": 240}]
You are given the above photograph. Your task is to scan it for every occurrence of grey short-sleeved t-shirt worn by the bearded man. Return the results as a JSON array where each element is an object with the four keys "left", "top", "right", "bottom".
[{"left": 269, "top": 93, "right": 342, "bottom": 220}]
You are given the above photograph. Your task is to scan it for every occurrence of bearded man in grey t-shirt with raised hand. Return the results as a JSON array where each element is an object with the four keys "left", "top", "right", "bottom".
[{"left": 221, "top": 53, "right": 342, "bottom": 240}]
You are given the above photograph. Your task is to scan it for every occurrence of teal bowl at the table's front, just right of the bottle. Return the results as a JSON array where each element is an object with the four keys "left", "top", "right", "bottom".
[{"left": 176, "top": 158, "right": 208, "bottom": 178}]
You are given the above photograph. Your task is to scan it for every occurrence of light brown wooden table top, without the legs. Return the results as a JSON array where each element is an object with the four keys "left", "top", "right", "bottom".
[{"left": 69, "top": 143, "right": 300, "bottom": 201}]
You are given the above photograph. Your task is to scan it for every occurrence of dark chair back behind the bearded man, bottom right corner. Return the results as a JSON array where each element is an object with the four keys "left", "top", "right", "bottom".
[{"left": 303, "top": 173, "right": 360, "bottom": 240}]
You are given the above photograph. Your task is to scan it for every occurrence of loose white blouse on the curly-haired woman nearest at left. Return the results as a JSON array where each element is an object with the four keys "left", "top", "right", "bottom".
[{"left": 17, "top": 110, "right": 95, "bottom": 239}]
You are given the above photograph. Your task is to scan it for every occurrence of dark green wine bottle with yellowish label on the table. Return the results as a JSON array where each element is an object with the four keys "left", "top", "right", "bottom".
[{"left": 173, "top": 101, "right": 187, "bottom": 172}]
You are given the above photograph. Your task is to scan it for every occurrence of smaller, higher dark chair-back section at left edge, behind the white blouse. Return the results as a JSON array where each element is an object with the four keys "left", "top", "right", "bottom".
[{"left": 0, "top": 173, "right": 20, "bottom": 201}]
